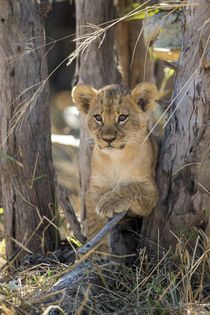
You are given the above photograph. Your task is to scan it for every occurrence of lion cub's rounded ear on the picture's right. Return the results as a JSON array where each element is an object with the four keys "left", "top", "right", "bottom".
[{"left": 131, "top": 82, "right": 157, "bottom": 112}]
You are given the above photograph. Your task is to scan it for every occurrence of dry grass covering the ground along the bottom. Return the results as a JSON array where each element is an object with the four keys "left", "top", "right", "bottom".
[{"left": 0, "top": 231, "right": 210, "bottom": 315}]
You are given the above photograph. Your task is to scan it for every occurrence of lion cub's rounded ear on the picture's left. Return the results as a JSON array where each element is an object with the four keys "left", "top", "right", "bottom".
[{"left": 72, "top": 84, "right": 97, "bottom": 114}]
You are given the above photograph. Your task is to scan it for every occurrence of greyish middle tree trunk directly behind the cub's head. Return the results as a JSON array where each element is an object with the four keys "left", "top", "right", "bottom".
[{"left": 76, "top": 0, "right": 121, "bottom": 221}]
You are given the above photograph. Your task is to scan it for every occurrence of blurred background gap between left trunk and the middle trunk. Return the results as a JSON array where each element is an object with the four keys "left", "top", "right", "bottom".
[{"left": 45, "top": 1, "right": 80, "bottom": 217}]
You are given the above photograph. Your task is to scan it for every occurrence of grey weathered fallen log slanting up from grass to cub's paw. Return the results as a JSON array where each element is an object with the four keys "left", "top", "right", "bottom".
[{"left": 25, "top": 211, "right": 127, "bottom": 315}]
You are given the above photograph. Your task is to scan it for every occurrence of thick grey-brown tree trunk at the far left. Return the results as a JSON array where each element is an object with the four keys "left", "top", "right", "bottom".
[{"left": 0, "top": 0, "right": 56, "bottom": 265}]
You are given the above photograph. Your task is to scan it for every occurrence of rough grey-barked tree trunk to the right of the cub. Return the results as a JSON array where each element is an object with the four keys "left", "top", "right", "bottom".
[{"left": 142, "top": 0, "right": 210, "bottom": 251}]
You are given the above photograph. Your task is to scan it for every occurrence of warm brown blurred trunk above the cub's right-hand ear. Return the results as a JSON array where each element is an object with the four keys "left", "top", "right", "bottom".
[{"left": 115, "top": 0, "right": 155, "bottom": 89}]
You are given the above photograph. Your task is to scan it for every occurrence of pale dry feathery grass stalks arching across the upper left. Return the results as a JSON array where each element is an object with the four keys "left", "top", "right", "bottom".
[{"left": 1, "top": 0, "right": 200, "bottom": 145}]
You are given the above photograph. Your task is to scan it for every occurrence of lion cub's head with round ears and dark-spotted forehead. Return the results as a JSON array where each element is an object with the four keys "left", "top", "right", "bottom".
[{"left": 72, "top": 82, "right": 157, "bottom": 152}]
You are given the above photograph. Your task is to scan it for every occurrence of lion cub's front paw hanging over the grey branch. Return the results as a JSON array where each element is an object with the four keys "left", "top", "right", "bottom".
[{"left": 96, "top": 193, "right": 129, "bottom": 218}]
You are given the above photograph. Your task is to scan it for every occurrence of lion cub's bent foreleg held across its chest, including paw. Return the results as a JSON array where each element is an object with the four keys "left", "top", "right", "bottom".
[{"left": 96, "top": 181, "right": 158, "bottom": 218}]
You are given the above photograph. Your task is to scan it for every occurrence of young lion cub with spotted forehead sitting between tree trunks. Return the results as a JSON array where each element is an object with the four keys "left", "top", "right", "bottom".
[{"left": 72, "top": 82, "right": 158, "bottom": 252}]
